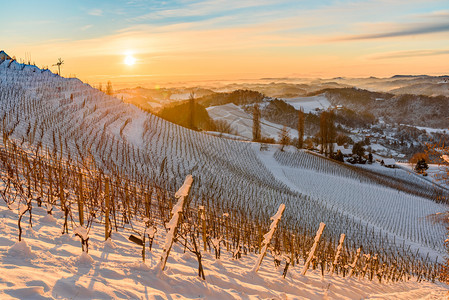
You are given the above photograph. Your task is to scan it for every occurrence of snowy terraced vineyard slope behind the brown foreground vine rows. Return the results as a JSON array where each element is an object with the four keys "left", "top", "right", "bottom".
[{"left": 0, "top": 61, "right": 447, "bottom": 262}]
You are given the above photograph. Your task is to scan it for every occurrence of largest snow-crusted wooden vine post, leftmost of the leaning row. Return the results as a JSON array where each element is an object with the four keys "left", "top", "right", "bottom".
[{"left": 156, "top": 175, "right": 193, "bottom": 272}]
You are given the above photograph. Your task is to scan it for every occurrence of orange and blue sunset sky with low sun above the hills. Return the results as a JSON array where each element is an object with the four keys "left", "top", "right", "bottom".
[{"left": 0, "top": 0, "right": 449, "bottom": 84}]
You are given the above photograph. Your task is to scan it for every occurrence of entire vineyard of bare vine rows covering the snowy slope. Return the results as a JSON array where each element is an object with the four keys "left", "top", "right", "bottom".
[{"left": 0, "top": 61, "right": 448, "bottom": 298}]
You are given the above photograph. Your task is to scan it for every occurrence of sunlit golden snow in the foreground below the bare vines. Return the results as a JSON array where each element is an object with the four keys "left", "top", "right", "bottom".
[{"left": 0, "top": 198, "right": 447, "bottom": 299}]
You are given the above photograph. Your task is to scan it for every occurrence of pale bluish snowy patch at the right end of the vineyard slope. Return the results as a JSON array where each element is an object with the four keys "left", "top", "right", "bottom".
[{"left": 259, "top": 147, "right": 448, "bottom": 259}]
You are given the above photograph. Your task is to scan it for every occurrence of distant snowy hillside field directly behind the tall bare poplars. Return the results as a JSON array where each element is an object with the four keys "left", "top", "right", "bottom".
[{"left": 207, "top": 103, "right": 298, "bottom": 140}]
